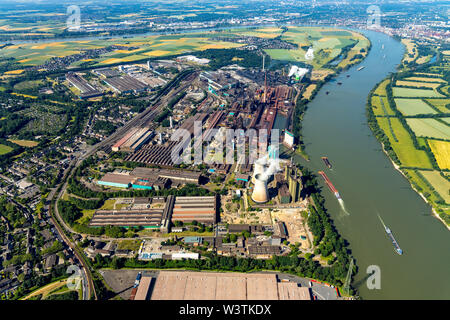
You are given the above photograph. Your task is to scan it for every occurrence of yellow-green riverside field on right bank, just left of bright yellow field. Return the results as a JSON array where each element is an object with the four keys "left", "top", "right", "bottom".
[{"left": 377, "top": 117, "right": 432, "bottom": 169}]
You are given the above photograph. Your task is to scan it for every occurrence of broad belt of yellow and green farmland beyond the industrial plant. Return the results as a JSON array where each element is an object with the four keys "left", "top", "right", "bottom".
[{"left": 0, "top": 27, "right": 369, "bottom": 74}]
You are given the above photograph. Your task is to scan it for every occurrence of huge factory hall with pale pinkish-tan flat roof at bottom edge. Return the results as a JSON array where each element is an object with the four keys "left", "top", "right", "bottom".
[{"left": 136, "top": 271, "right": 311, "bottom": 300}]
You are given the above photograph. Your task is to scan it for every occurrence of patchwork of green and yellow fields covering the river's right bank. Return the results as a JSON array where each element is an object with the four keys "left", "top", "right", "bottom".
[{"left": 366, "top": 45, "right": 450, "bottom": 230}]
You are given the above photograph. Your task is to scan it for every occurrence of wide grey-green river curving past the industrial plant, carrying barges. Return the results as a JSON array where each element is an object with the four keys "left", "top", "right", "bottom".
[{"left": 286, "top": 31, "right": 450, "bottom": 299}]
